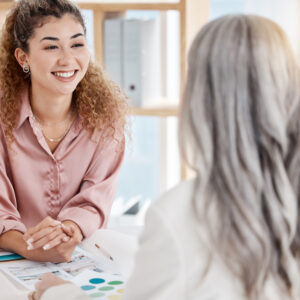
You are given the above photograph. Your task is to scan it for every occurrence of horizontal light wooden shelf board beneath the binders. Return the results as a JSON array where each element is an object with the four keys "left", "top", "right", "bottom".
[{"left": 130, "top": 106, "right": 178, "bottom": 118}]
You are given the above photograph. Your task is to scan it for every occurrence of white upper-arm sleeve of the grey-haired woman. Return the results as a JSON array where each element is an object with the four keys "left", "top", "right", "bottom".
[{"left": 122, "top": 207, "right": 185, "bottom": 300}]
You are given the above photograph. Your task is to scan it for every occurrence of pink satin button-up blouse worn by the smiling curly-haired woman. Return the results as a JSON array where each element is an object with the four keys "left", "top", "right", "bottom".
[{"left": 0, "top": 86, "right": 124, "bottom": 237}]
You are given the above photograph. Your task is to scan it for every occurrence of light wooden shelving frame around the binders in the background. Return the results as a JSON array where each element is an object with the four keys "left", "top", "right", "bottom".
[{"left": 76, "top": 0, "right": 209, "bottom": 117}]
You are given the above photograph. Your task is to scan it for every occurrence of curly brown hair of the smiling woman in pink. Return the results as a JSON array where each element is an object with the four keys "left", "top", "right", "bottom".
[{"left": 0, "top": 0, "right": 128, "bottom": 144}]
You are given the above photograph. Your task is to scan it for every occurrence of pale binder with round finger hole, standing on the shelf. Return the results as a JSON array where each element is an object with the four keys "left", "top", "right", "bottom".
[{"left": 123, "top": 19, "right": 161, "bottom": 106}]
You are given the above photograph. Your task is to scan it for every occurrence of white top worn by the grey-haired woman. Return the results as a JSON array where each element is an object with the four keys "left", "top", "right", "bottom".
[{"left": 42, "top": 181, "right": 282, "bottom": 300}]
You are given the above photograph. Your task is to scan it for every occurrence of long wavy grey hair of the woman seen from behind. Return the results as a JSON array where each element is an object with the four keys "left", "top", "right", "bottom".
[{"left": 179, "top": 15, "right": 300, "bottom": 299}]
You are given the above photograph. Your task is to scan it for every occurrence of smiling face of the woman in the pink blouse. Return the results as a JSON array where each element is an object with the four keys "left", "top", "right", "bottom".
[{"left": 16, "top": 14, "right": 90, "bottom": 96}]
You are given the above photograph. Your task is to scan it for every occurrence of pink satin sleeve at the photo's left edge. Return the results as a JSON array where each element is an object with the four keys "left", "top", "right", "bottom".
[{"left": 0, "top": 129, "right": 26, "bottom": 234}]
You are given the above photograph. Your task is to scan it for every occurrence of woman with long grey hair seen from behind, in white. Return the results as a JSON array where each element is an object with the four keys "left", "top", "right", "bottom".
[{"left": 33, "top": 15, "right": 300, "bottom": 300}]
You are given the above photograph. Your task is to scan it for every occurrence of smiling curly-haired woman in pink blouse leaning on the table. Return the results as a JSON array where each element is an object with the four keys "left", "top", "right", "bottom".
[{"left": 0, "top": 0, "right": 127, "bottom": 262}]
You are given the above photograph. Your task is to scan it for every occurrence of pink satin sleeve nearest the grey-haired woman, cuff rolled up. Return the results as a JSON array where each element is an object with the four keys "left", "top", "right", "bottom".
[{"left": 57, "top": 138, "right": 125, "bottom": 238}]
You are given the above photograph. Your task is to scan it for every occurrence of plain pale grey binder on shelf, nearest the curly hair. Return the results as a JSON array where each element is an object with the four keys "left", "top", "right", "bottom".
[{"left": 104, "top": 19, "right": 123, "bottom": 88}]
